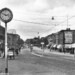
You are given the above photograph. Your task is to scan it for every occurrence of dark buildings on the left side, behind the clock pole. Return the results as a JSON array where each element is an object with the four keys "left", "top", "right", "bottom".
[{"left": 0, "top": 25, "right": 24, "bottom": 52}]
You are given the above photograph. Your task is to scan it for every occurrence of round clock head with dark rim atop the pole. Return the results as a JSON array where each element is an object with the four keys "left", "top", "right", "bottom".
[{"left": 0, "top": 8, "right": 13, "bottom": 23}]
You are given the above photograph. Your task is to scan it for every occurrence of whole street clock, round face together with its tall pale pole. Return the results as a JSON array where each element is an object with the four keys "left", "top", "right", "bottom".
[{"left": 0, "top": 8, "right": 13, "bottom": 75}]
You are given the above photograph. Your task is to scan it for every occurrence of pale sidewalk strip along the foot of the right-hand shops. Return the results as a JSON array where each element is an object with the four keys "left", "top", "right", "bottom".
[{"left": 34, "top": 47, "right": 74, "bottom": 57}]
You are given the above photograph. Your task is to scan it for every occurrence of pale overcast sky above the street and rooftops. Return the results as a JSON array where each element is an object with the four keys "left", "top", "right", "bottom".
[{"left": 0, "top": 0, "right": 75, "bottom": 40}]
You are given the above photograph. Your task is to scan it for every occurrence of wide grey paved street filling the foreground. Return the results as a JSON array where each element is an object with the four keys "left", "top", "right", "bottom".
[{"left": 0, "top": 48, "right": 75, "bottom": 75}]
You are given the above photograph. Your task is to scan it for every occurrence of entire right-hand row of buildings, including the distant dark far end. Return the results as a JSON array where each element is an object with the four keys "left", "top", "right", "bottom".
[{"left": 26, "top": 28, "right": 75, "bottom": 53}]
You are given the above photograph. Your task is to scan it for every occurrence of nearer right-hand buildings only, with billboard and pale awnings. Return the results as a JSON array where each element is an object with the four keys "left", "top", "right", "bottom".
[{"left": 46, "top": 28, "right": 75, "bottom": 53}]
